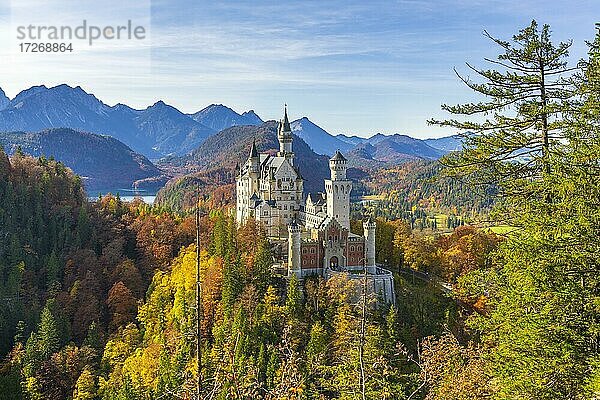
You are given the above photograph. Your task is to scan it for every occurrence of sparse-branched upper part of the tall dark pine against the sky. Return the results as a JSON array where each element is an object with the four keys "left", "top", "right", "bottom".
[{"left": 428, "top": 20, "right": 575, "bottom": 219}]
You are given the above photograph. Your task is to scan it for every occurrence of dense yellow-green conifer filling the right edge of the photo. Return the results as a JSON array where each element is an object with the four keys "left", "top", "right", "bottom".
[{"left": 464, "top": 26, "right": 600, "bottom": 399}]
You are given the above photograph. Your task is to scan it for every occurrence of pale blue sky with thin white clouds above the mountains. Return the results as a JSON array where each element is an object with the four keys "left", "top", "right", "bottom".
[{"left": 0, "top": 0, "right": 600, "bottom": 137}]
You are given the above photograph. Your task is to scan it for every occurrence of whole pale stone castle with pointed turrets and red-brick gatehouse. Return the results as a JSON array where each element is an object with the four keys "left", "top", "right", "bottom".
[{"left": 236, "top": 108, "right": 394, "bottom": 302}]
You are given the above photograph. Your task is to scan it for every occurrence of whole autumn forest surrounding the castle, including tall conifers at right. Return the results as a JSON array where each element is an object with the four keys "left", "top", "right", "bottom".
[{"left": 0, "top": 21, "right": 600, "bottom": 400}]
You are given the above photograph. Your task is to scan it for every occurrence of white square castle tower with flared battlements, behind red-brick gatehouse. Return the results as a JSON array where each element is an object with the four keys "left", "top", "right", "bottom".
[{"left": 325, "top": 151, "right": 352, "bottom": 230}]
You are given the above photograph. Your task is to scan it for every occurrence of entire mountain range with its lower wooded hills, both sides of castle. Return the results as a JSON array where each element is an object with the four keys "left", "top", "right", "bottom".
[{"left": 0, "top": 84, "right": 462, "bottom": 195}]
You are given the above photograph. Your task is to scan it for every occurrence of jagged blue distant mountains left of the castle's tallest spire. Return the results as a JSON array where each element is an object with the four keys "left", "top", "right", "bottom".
[{"left": 0, "top": 84, "right": 262, "bottom": 159}]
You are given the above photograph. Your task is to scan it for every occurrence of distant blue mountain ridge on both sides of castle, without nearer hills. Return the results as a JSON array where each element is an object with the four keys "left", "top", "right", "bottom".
[{"left": 0, "top": 84, "right": 460, "bottom": 162}]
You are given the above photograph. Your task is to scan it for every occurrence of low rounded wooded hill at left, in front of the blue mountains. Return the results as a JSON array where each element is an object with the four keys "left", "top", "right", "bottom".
[{"left": 0, "top": 128, "right": 167, "bottom": 191}]
